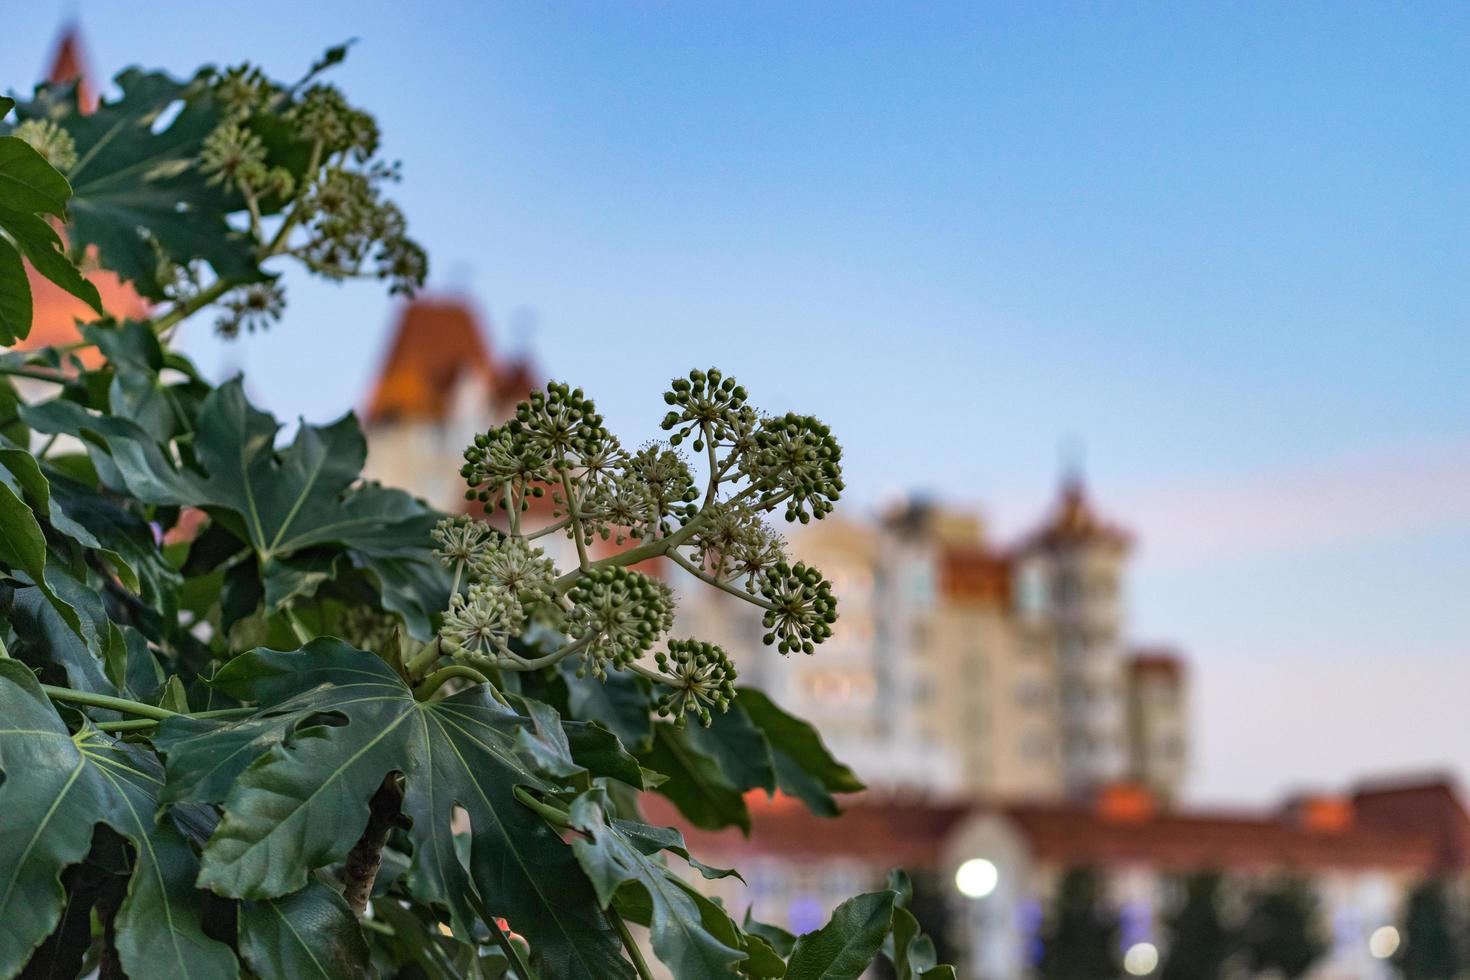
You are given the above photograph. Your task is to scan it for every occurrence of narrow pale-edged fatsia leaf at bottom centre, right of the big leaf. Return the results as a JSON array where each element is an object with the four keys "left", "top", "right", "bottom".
[{"left": 567, "top": 789, "right": 745, "bottom": 980}]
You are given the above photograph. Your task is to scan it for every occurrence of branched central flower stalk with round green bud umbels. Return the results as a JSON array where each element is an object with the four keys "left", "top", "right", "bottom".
[{"left": 426, "top": 369, "right": 842, "bottom": 726}]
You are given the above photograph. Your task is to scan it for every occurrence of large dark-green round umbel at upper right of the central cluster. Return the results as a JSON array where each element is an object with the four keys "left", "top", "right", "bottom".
[{"left": 742, "top": 413, "right": 842, "bottom": 525}]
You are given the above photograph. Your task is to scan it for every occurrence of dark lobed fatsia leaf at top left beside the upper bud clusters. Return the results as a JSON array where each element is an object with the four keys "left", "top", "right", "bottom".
[{"left": 18, "top": 69, "right": 262, "bottom": 300}]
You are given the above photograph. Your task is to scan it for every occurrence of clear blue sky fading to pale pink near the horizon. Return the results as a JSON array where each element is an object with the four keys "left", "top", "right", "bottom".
[{"left": 0, "top": 1, "right": 1470, "bottom": 799}]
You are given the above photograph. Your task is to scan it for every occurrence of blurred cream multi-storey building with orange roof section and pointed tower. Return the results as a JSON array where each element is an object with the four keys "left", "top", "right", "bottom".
[{"left": 679, "top": 478, "right": 1188, "bottom": 801}]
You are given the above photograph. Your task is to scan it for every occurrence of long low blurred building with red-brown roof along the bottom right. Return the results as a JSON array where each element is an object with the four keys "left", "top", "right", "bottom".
[{"left": 670, "top": 777, "right": 1470, "bottom": 980}]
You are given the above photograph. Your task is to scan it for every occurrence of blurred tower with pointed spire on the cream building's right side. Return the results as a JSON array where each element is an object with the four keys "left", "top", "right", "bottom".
[{"left": 1016, "top": 476, "right": 1129, "bottom": 795}]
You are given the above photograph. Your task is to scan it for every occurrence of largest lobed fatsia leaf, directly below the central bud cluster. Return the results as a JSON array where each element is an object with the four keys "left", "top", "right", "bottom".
[{"left": 157, "top": 639, "right": 631, "bottom": 980}]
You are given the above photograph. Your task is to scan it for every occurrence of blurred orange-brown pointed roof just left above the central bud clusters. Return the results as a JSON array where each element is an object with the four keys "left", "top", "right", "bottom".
[{"left": 365, "top": 297, "right": 537, "bottom": 425}]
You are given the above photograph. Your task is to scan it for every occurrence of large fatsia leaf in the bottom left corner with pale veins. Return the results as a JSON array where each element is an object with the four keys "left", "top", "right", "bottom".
[{"left": 0, "top": 660, "right": 238, "bottom": 980}]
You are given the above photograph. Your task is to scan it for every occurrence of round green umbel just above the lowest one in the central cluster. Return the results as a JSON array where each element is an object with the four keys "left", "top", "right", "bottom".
[{"left": 566, "top": 569, "right": 673, "bottom": 677}]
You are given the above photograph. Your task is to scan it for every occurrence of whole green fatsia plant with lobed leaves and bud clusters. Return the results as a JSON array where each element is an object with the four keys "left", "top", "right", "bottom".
[{"left": 0, "top": 48, "right": 954, "bottom": 980}]
